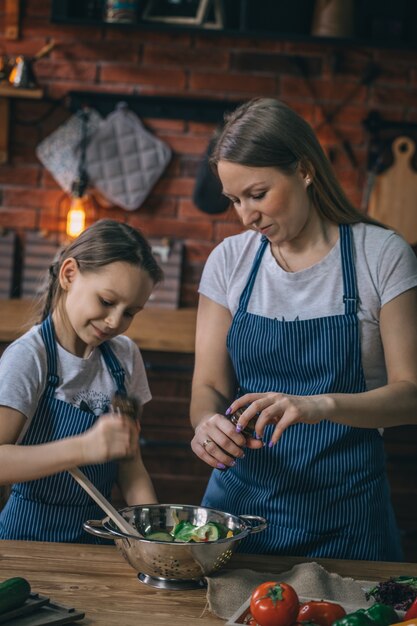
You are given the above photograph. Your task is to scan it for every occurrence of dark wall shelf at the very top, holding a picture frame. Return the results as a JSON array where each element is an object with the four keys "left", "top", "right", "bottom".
[{"left": 51, "top": 0, "right": 417, "bottom": 50}]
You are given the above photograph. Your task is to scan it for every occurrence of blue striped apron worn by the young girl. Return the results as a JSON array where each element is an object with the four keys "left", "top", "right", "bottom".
[{"left": 0, "top": 316, "right": 125, "bottom": 543}]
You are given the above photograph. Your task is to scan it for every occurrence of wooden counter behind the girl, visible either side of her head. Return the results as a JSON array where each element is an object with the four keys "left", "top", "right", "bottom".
[{"left": 0, "top": 299, "right": 196, "bottom": 353}]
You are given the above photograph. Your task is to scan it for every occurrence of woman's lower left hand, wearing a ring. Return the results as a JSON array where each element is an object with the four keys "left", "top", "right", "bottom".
[{"left": 191, "top": 413, "right": 263, "bottom": 469}]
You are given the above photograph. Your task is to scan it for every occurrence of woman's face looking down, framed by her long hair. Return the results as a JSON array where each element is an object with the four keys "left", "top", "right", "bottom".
[{"left": 217, "top": 161, "right": 313, "bottom": 244}]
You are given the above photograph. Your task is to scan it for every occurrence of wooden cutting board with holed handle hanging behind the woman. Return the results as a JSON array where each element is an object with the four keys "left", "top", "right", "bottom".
[{"left": 368, "top": 137, "right": 417, "bottom": 244}]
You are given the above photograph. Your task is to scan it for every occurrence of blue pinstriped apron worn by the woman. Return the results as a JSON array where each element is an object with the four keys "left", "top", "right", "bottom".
[{"left": 203, "top": 225, "right": 403, "bottom": 561}]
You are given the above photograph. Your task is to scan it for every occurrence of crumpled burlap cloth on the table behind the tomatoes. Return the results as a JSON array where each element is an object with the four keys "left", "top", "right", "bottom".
[{"left": 207, "top": 562, "right": 372, "bottom": 619}]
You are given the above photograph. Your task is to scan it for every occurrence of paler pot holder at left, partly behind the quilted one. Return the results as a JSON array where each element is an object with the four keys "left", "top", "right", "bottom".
[{"left": 36, "top": 109, "right": 103, "bottom": 193}]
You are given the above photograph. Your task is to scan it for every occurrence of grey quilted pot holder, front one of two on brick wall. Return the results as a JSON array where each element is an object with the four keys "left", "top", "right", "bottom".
[{"left": 86, "top": 103, "right": 172, "bottom": 211}]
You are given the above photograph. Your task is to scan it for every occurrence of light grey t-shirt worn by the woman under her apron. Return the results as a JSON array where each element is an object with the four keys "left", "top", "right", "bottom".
[{"left": 199, "top": 223, "right": 417, "bottom": 389}]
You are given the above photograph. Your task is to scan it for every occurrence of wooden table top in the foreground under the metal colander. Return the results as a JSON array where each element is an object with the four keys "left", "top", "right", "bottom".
[{"left": 0, "top": 541, "right": 417, "bottom": 626}]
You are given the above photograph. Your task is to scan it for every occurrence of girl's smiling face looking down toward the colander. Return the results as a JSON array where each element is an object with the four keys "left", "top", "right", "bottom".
[{"left": 53, "top": 257, "right": 154, "bottom": 357}]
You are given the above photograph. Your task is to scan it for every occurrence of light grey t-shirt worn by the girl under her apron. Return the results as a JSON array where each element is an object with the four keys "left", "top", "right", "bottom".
[{"left": 0, "top": 325, "right": 151, "bottom": 421}]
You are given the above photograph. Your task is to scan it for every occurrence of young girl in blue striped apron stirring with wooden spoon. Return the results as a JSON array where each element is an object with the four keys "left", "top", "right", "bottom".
[{"left": 0, "top": 220, "right": 163, "bottom": 543}]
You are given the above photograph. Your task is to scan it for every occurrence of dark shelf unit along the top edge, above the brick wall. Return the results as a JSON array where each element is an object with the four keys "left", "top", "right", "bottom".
[{"left": 51, "top": 0, "right": 417, "bottom": 48}]
